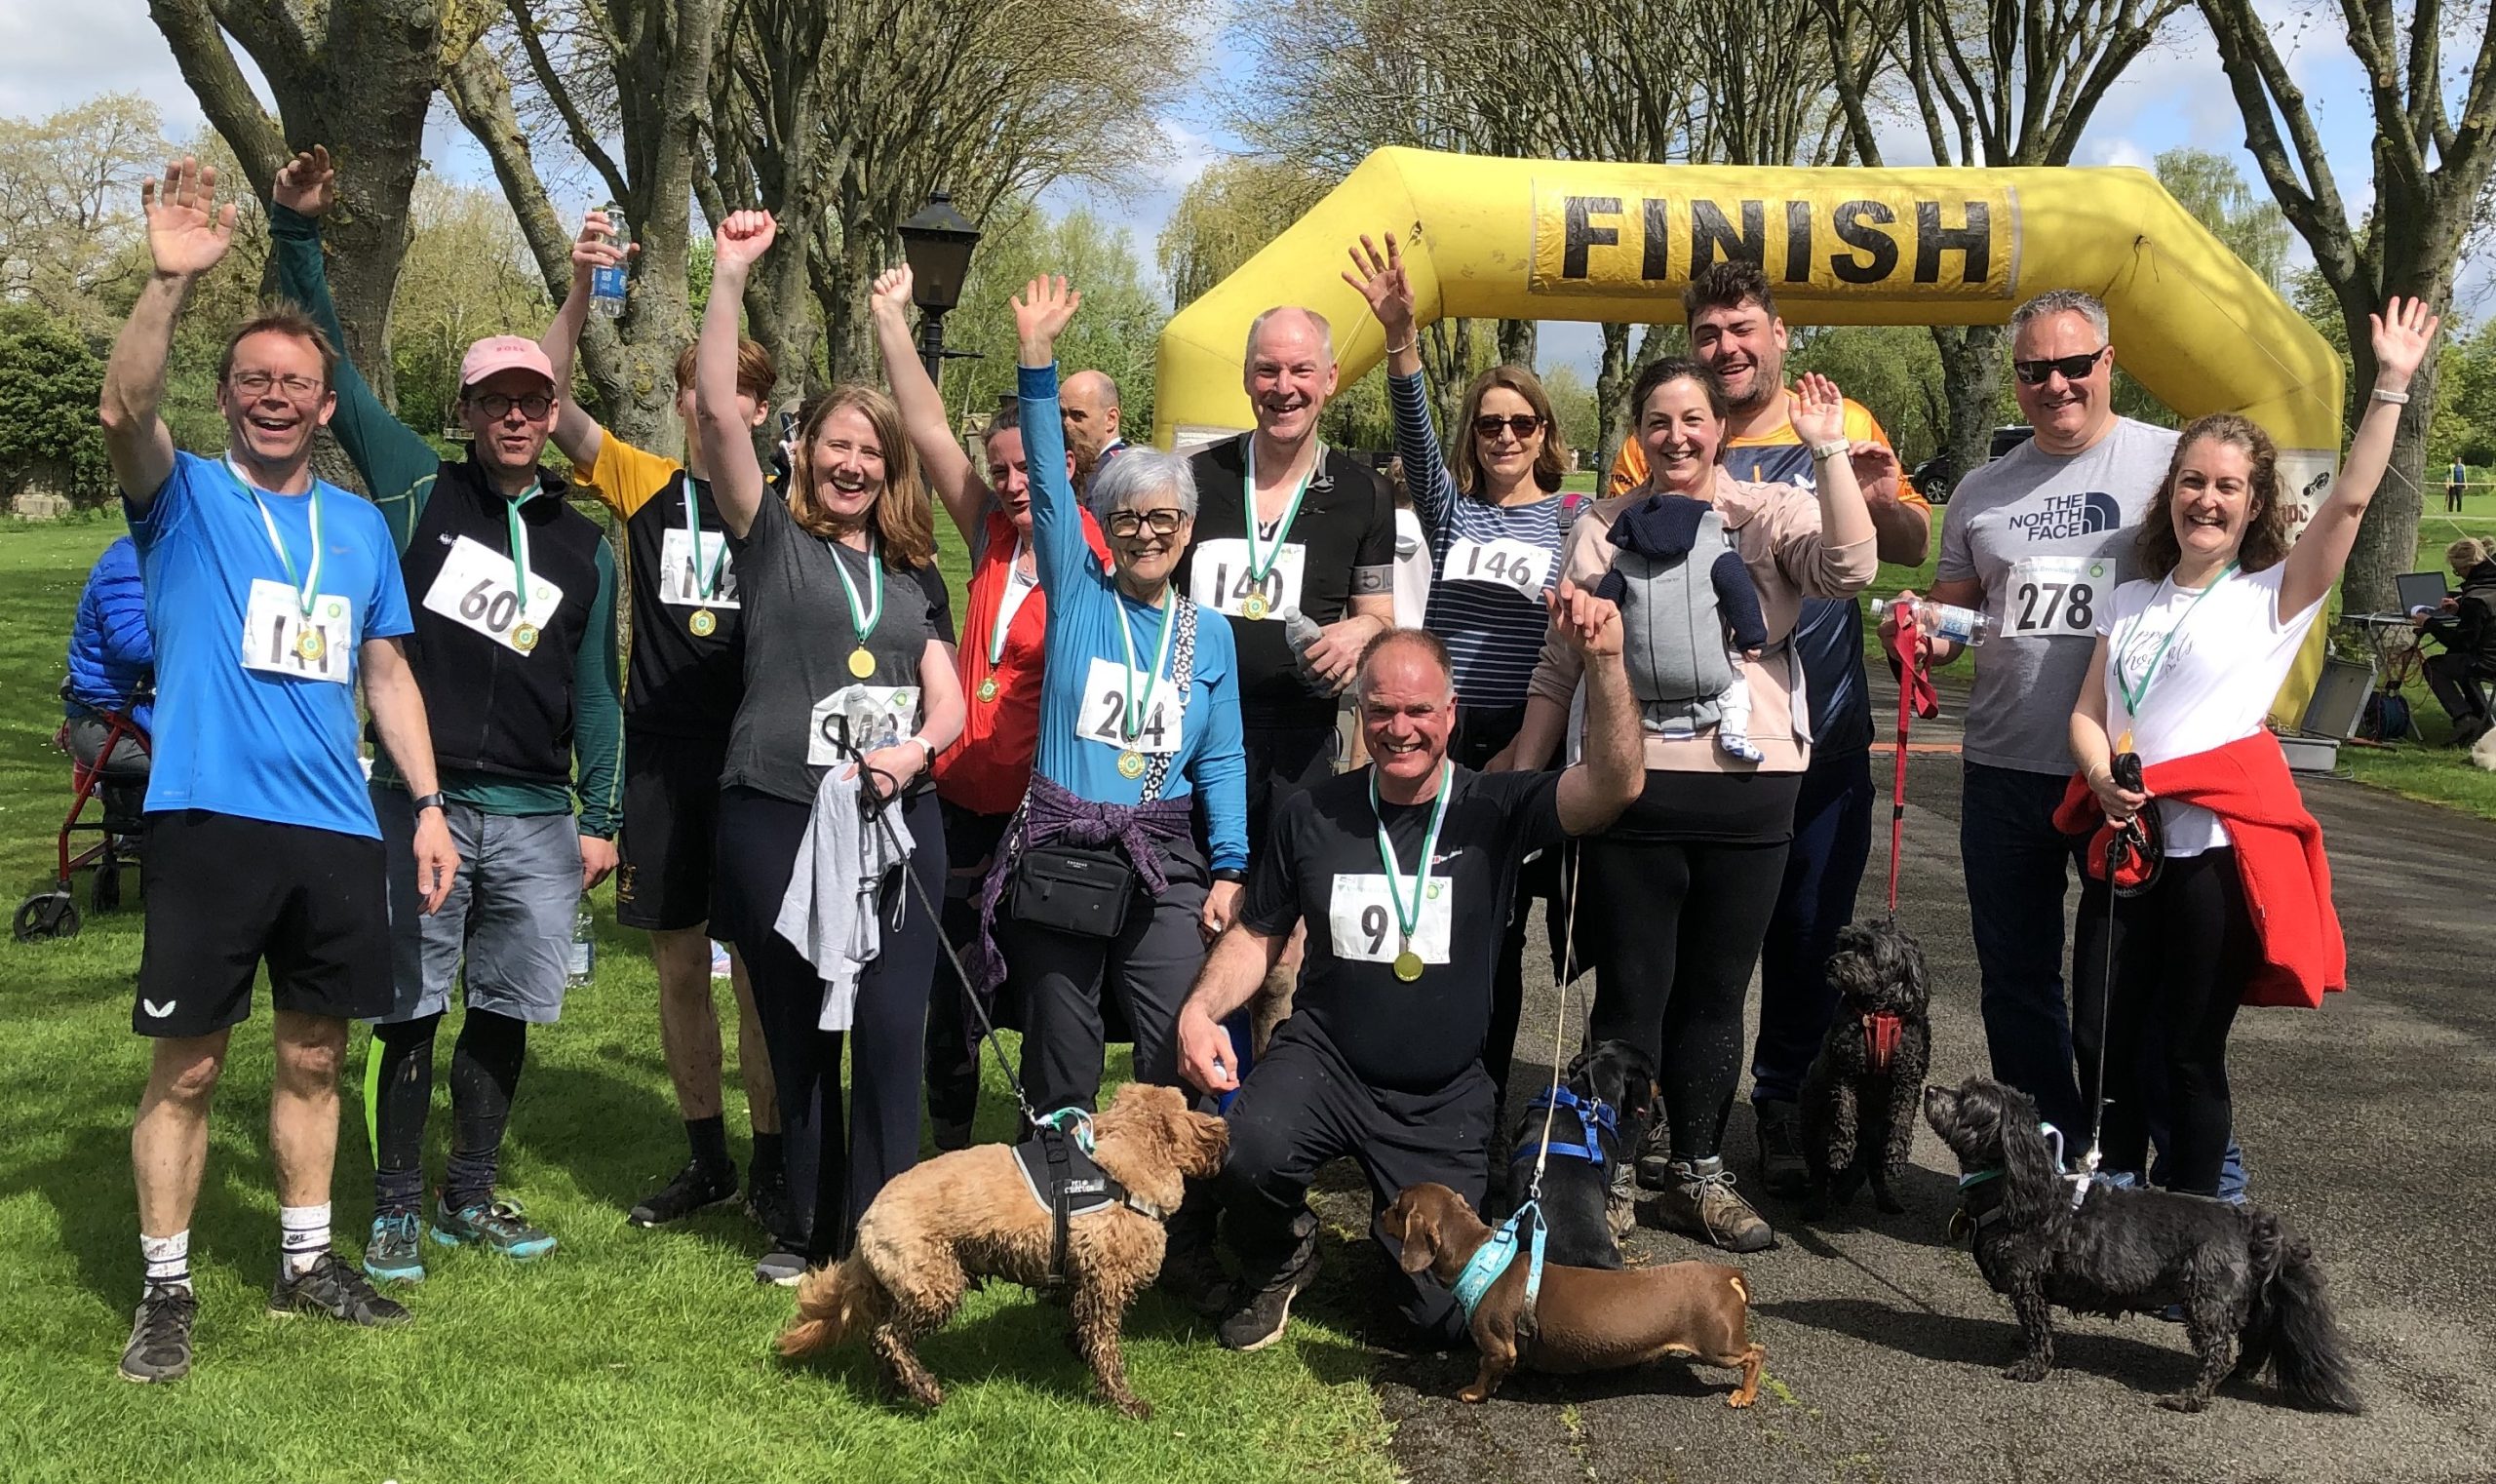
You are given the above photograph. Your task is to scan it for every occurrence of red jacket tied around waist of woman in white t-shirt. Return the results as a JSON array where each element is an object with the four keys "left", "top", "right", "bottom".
[{"left": 2054, "top": 730, "right": 2349, "bottom": 1010}]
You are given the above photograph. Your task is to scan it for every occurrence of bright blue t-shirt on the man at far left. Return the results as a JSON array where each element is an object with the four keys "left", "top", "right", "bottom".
[{"left": 130, "top": 454, "right": 414, "bottom": 838}]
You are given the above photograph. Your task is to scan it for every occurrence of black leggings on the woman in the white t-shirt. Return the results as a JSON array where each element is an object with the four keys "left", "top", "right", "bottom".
[{"left": 2067, "top": 848, "right": 2261, "bottom": 1194}]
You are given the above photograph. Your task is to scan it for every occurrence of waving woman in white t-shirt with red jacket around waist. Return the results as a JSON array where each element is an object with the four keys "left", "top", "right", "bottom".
[{"left": 2072, "top": 299, "right": 2437, "bottom": 1194}]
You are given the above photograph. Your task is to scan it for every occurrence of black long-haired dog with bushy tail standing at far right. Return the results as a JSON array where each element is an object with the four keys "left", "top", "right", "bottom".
[{"left": 1925, "top": 1077, "right": 2363, "bottom": 1412}]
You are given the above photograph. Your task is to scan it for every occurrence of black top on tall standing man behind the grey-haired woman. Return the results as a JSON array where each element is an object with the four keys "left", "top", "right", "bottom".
[{"left": 1178, "top": 434, "right": 1395, "bottom": 725}]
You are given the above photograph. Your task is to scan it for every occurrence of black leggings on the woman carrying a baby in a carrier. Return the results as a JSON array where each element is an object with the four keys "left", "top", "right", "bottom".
[{"left": 1578, "top": 836, "right": 1787, "bottom": 1159}]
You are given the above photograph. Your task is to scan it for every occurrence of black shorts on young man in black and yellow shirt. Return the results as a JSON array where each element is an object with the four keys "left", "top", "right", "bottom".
[{"left": 616, "top": 730, "right": 729, "bottom": 933}]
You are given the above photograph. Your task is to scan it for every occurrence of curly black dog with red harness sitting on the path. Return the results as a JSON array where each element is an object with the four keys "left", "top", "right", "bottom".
[{"left": 1802, "top": 922, "right": 1931, "bottom": 1220}]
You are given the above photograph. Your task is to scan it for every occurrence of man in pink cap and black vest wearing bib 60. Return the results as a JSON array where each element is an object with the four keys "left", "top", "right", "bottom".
[{"left": 269, "top": 149, "right": 624, "bottom": 1282}]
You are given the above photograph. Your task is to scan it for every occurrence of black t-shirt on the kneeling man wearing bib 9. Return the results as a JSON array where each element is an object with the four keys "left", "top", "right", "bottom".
[{"left": 1240, "top": 768, "right": 1563, "bottom": 1092}]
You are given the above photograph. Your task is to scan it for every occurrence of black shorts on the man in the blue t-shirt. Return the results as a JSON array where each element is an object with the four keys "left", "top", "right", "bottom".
[{"left": 130, "top": 808, "right": 394, "bottom": 1035}]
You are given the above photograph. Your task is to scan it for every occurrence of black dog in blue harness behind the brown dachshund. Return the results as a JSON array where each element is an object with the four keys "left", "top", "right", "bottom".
[{"left": 1507, "top": 1040, "right": 1655, "bottom": 1267}]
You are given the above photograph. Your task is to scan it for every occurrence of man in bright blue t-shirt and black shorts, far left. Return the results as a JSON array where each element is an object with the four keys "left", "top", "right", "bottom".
[{"left": 102, "top": 160, "right": 459, "bottom": 1382}]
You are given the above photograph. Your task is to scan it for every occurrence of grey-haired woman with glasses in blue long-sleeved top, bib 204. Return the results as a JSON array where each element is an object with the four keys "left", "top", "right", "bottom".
[{"left": 979, "top": 279, "right": 1248, "bottom": 1114}]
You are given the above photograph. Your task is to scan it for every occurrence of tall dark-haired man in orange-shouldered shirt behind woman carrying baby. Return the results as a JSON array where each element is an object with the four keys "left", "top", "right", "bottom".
[{"left": 1610, "top": 262, "right": 1931, "bottom": 1197}]
